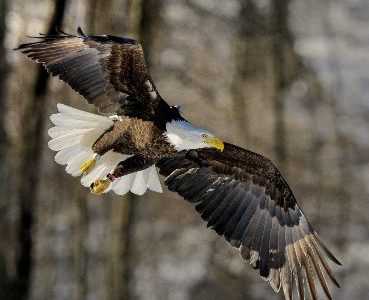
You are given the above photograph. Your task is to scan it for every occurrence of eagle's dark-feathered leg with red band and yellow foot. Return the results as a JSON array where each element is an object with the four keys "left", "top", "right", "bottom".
[{"left": 90, "top": 154, "right": 158, "bottom": 195}]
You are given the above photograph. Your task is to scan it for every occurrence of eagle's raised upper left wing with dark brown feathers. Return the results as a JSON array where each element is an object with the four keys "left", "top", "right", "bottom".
[{"left": 17, "top": 28, "right": 180, "bottom": 126}]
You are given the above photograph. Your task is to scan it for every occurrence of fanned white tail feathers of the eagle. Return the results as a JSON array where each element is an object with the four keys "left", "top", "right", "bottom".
[{"left": 48, "top": 103, "right": 162, "bottom": 195}]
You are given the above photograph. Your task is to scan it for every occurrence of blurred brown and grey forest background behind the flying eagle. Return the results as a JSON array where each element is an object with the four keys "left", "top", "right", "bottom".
[{"left": 0, "top": 0, "right": 369, "bottom": 300}]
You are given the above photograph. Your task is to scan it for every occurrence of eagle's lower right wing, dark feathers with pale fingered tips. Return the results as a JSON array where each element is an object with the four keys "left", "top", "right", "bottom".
[{"left": 157, "top": 144, "right": 340, "bottom": 299}]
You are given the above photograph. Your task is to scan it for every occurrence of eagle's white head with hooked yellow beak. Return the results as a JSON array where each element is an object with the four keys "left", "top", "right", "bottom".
[{"left": 164, "top": 121, "right": 224, "bottom": 151}]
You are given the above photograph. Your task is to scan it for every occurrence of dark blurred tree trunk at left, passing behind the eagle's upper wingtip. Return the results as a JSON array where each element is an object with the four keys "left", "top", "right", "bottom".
[{"left": 14, "top": 0, "right": 66, "bottom": 299}]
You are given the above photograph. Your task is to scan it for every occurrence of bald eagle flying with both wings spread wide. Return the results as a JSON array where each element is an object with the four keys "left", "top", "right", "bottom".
[{"left": 17, "top": 28, "right": 340, "bottom": 299}]
